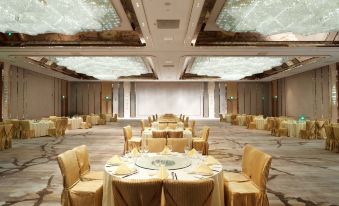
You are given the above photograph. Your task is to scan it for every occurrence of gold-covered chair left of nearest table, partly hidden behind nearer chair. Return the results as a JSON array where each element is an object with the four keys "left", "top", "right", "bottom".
[{"left": 73, "top": 145, "right": 104, "bottom": 181}]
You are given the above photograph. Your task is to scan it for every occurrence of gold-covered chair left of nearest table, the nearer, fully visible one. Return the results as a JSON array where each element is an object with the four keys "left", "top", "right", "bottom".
[{"left": 57, "top": 150, "right": 103, "bottom": 206}]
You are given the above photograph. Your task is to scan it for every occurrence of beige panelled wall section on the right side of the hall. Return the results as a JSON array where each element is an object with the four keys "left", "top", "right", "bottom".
[{"left": 278, "top": 67, "right": 331, "bottom": 119}]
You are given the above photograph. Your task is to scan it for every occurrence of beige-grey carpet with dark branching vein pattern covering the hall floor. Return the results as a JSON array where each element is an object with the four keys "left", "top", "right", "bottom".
[{"left": 0, "top": 120, "right": 339, "bottom": 206}]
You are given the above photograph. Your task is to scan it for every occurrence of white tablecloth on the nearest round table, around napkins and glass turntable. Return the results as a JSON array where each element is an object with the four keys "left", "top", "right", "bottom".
[{"left": 102, "top": 153, "right": 224, "bottom": 206}]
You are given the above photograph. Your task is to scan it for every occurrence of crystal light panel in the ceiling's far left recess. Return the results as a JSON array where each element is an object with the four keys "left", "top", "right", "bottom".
[{"left": 50, "top": 57, "right": 149, "bottom": 80}]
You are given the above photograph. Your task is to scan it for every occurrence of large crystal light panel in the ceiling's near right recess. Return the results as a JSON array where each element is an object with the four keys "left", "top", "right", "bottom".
[{"left": 216, "top": 0, "right": 339, "bottom": 35}]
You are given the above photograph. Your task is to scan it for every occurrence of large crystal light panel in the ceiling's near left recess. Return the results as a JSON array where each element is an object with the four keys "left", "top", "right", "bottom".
[{"left": 0, "top": 0, "right": 120, "bottom": 35}]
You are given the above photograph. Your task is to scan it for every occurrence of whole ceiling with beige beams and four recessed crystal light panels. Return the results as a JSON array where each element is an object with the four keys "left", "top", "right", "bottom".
[{"left": 0, "top": 0, "right": 339, "bottom": 81}]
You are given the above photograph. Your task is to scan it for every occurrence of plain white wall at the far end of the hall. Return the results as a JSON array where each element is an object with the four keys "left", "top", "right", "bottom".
[{"left": 136, "top": 82, "right": 203, "bottom": 118}]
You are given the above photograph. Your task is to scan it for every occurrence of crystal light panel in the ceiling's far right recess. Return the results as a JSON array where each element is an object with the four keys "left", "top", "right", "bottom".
[{"left": 189, "top": 57, "right": 286, "bottom": 80}]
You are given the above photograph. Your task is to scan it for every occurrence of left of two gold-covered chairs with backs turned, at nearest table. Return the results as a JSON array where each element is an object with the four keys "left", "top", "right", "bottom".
[{"left": 112, "top": 178, "right": 163, "bottom": 206}]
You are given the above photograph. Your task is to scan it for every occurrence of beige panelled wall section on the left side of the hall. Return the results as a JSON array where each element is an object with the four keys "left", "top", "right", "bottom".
[{"left": 8, "top": 66, "right": 66, "bottom": 119}]
